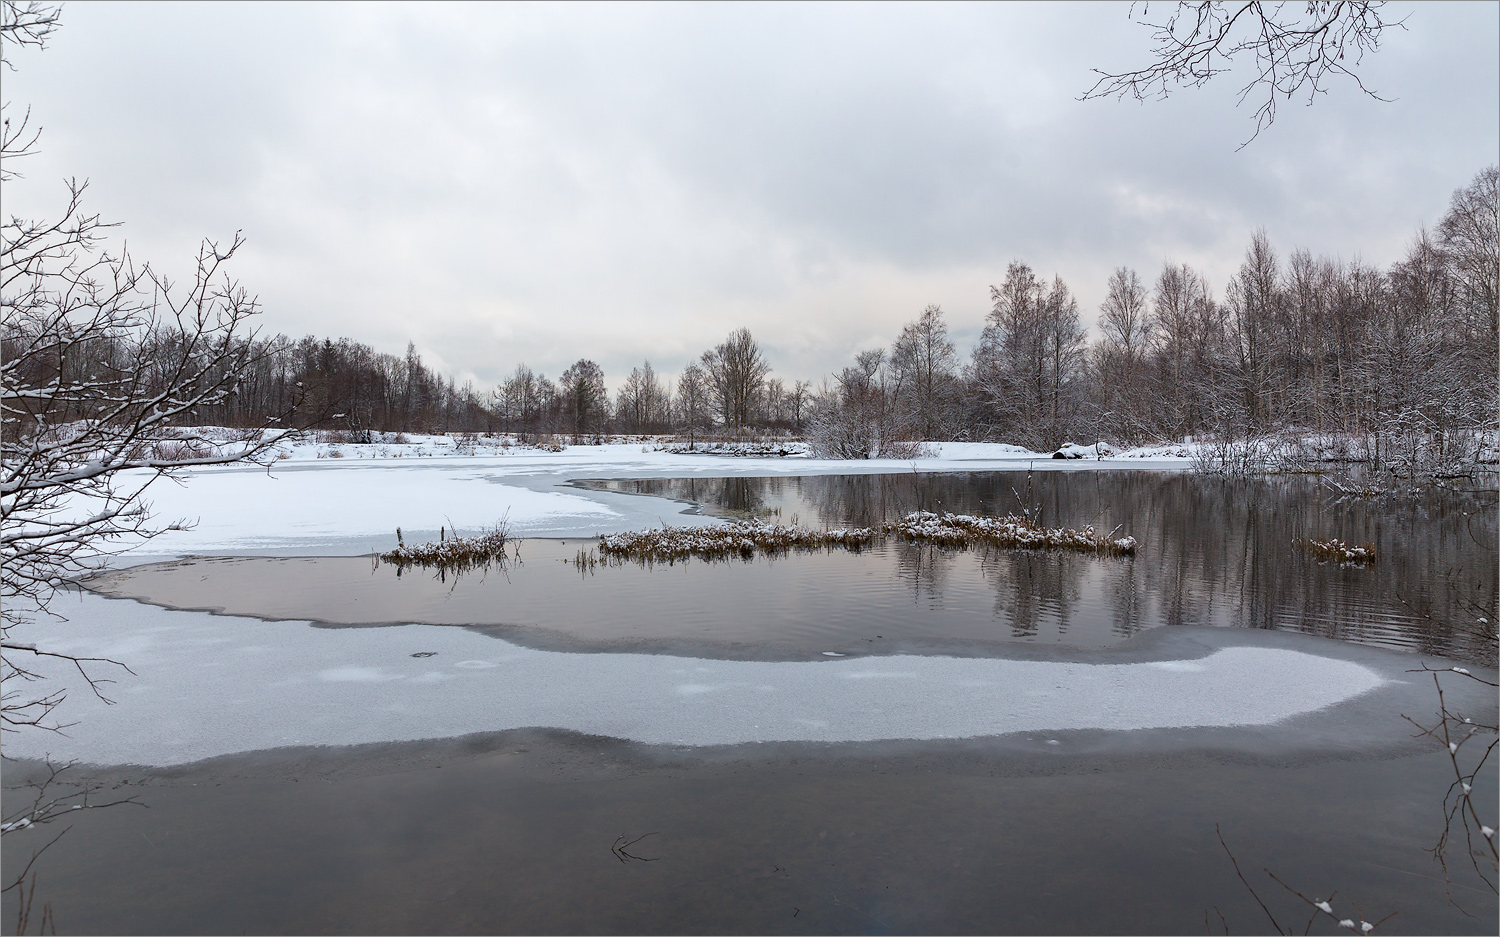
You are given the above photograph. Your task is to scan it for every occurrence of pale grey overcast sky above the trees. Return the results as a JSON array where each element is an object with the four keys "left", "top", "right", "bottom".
[{"left": 3, "top": 1, "right": 1500, "bottom": 385}]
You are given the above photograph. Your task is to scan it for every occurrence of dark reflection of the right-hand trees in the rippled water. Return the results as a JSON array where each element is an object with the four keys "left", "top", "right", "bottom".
[{"left": 590, "top": 471, "right": 1500, "bottom": 663}]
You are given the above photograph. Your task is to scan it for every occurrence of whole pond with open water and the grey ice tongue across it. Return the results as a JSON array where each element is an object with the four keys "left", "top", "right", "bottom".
[{"left": 0, "top": 469, "right": 1496, "bottom": 934}]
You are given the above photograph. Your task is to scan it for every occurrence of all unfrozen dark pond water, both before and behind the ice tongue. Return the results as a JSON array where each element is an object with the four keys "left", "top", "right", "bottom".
[{"left": 0, "top": 472, "right": 1497, "bottom": 934}]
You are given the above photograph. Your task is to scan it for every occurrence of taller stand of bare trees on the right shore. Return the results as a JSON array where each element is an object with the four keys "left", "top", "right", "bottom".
[{"left": 815, "top": 166, "right": 1500, "bottom": 463}]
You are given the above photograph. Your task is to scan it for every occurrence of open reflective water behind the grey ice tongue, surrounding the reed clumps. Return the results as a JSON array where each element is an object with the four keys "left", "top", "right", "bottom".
[{"left": 92, "top": 472, "right": 1500, "bottom": 664}]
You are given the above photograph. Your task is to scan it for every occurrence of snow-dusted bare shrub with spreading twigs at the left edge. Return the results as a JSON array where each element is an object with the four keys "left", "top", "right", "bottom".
[{"left": 0, "top": 3, "right": 291, "bottom": 730}]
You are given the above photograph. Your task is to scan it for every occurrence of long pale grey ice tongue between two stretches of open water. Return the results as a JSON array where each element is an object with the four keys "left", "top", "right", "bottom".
[{"left": 6, "top": 594, "right": 1410, "bottom": 765}]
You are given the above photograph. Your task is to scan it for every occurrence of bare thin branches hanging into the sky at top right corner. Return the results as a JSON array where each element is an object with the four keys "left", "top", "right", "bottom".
[{"left": 1080, "top": 0, "right": 1406, "bottom": 147}]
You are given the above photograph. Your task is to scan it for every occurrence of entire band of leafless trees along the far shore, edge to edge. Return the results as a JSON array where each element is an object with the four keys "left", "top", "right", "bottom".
[{"left": 3, "top": 166, "right": 1500, "bottom": 457}]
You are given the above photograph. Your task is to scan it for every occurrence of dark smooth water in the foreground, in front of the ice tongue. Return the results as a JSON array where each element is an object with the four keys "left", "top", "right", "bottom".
[{"left": 3, "top": 732, "right": 1496, "bottom": 934}]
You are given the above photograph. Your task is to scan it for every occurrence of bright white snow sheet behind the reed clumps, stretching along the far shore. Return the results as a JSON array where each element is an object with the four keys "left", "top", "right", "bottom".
[{"left": 114, "top": 436, "right": 1188, "bottom": 562}]
